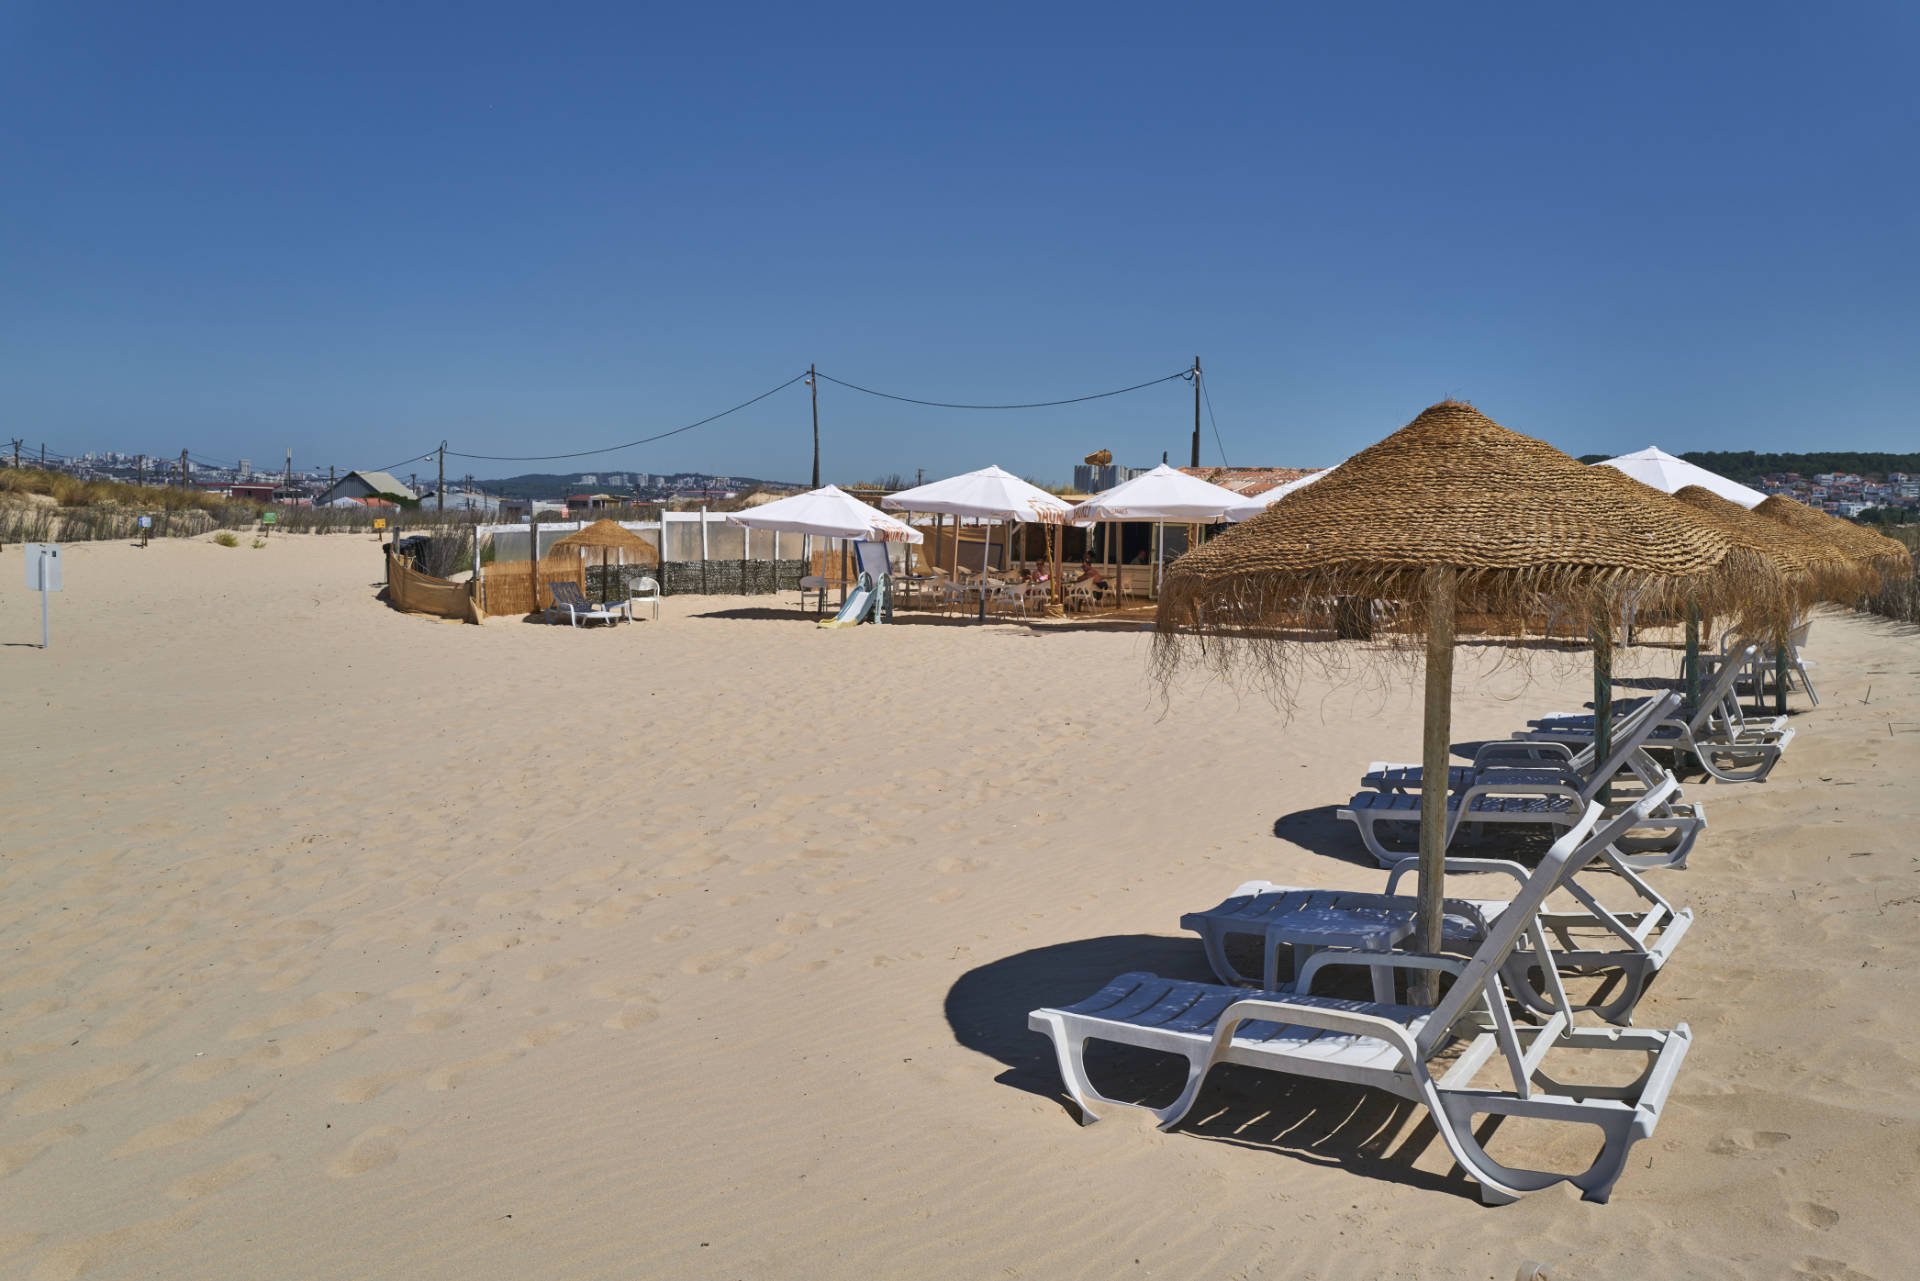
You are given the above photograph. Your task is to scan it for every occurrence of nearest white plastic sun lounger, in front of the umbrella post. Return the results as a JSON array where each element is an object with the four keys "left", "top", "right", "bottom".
[{"left": 1027, "top": 793, "right": 1692, "bottom": 1204}]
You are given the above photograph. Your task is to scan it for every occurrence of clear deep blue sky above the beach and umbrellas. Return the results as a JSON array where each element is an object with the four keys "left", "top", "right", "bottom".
[{"left": 0, "top": 0, "right": 1920, "bottom": 480}]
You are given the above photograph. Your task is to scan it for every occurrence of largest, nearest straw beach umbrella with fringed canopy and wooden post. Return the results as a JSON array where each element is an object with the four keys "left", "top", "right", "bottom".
[{"left": 1156, "top": 401, "right": 1749, "bottom": 983}]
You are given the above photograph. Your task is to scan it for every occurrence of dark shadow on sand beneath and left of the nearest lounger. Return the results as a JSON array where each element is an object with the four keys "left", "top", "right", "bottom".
[{"left": 947, "top": 933, "right": 1476, "bottom": 1198}]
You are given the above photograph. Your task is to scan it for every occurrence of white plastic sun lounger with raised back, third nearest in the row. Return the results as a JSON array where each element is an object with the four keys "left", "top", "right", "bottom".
[{"left": 1334, "top": 693, "right": 1707, "bottom": 868}]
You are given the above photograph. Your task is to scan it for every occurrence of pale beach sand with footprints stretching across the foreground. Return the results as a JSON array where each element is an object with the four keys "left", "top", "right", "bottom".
[{"left": 0, "top": 536, "right": 1920, "bottom": 1281}]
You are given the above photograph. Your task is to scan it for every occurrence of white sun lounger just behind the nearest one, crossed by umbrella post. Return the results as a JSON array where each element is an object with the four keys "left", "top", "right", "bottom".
[{"left": 1181, "top": 776, "right": 1693, "bottom": 1024}]
